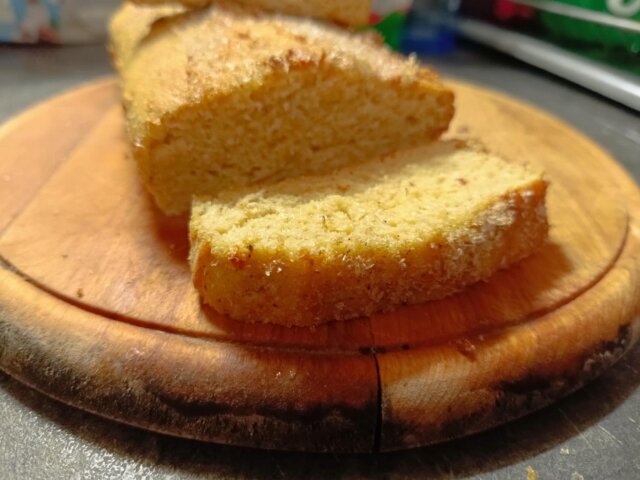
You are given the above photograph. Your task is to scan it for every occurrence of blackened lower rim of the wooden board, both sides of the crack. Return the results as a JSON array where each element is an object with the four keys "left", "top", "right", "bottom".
[{"left": 0, "top": 253, "right": 640, "bottom": 453}]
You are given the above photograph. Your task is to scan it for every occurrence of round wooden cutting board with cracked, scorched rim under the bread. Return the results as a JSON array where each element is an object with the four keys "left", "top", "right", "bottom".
[{"left": 0, "top": 79, "right": 640, "bottom": 452}]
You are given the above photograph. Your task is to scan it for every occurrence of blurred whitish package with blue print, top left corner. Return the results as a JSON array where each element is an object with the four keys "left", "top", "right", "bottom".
[{"left": 0, "top": 0, "right": 120, "bottom": 44}]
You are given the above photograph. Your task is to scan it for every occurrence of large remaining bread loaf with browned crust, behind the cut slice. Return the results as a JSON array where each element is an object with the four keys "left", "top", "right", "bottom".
[{"left": 111, "top": 3, "right": 453, "bottom": 214}]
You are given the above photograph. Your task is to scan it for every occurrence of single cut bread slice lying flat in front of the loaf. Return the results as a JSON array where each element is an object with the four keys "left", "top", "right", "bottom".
[{"left": 190, "top": 141, "right": 547, "bottom": 326}]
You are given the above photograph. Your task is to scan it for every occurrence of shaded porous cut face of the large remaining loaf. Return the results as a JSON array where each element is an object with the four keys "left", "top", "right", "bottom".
[{"left": 148, "top": 65, "right": 448, "bottom": 212}]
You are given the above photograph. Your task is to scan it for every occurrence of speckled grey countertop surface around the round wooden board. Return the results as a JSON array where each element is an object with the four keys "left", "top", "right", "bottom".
[{"left": 0, "top": 45, "right": 640, "bottom": 480}]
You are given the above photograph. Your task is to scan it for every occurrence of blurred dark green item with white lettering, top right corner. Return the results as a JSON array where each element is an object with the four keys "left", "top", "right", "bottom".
[{"left": 540, "top": 0, "right": 640, "bottom": 54}]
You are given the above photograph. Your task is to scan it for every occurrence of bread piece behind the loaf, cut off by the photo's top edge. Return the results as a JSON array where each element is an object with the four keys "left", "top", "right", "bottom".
[{"left": 126, "top": 0, "right": 371, "bottom": 25}]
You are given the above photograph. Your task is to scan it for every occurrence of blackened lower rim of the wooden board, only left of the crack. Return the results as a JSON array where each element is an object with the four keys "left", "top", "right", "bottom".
[{"left": 0, "top": 300, "right": 379, "bottom": 453}]
